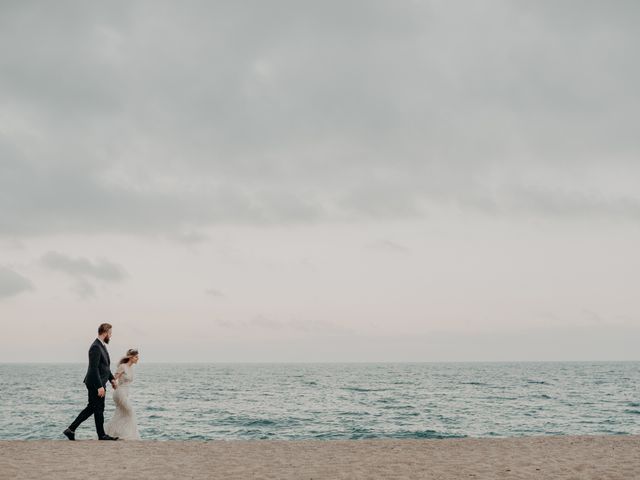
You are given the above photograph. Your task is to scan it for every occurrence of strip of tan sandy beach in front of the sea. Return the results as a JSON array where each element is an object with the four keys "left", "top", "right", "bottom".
[{"left": 0, "top": 435, "right": 640, "bottom": 480}]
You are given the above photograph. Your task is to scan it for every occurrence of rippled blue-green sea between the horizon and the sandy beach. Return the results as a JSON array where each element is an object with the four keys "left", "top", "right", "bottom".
[{"left": 0, "top": 362, "right": 640, "bottom": 440}]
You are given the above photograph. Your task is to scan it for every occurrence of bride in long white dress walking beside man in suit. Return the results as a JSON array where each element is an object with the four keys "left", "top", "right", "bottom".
[{"left": 105, "top": 348, "right": 140, "bottom": 440}]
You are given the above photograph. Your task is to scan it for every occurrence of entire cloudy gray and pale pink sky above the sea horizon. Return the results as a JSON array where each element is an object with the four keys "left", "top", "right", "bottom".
[{"left": 0, "top": 0, "right": 640, "bottom": 362}]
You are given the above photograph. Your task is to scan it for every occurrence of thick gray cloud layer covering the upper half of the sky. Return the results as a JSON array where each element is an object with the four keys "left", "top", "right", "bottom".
[{"left": 0, "top": 1, "right": 640, "bottom": 235}]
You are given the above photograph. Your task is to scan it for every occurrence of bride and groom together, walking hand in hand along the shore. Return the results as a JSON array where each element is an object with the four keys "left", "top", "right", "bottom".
[{"left": 63, "top": 323, "right": 140, "bottom": 440}]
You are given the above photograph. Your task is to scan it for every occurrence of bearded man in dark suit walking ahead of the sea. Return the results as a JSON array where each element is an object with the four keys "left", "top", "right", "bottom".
[{"left": 63, "top": 323, "right": 118, "bottom": 440}]
